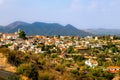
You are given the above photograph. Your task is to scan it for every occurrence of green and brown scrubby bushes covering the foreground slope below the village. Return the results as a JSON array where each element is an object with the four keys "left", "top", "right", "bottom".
[{"left": 0, "top": 47, "right": 120, "bottom": 80}]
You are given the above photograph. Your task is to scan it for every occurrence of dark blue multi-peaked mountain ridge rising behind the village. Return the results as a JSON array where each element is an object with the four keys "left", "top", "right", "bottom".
[{"left": 0, "top": 21, "right": 93, "bottom": 37}]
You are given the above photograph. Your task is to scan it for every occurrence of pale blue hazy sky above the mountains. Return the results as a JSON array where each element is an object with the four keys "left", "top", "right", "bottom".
[{"left": 0, "top": 0, "right": 120, "bottom": 29}]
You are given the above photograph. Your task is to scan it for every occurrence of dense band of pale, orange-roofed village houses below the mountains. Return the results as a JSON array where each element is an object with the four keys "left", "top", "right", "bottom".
[{"left": 0, "top": 32, "right": 102, "bottom": 53}]
